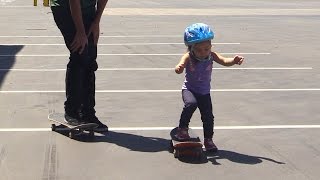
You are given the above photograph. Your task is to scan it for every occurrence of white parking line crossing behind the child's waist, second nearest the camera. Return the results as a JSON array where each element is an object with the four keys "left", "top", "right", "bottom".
[{"left": 0, "top": 88, "right": 320, "bottom": 94}]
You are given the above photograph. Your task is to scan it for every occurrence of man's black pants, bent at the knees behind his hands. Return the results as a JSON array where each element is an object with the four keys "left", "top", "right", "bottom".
[{"left": 51, "top": 7, "right": 98, "bottom": 119}]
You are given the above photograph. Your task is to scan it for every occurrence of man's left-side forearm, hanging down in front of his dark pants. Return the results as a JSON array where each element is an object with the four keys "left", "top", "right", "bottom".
[{"left": 69, "top": 0, "right": 85, "bottom": 32}]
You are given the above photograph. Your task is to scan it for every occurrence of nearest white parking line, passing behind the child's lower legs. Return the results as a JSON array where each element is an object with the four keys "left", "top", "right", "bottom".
[{"left": 0, "top": 124, "right": 320, "bottom": 132}]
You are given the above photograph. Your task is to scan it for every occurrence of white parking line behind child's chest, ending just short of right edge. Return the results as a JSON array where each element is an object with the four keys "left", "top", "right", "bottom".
[{"left": 0, "top": 67, "right": 313, "bottom": 72}]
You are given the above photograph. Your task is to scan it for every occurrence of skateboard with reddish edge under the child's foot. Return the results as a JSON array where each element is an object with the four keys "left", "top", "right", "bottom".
[{"left": 170, "top": 127, "right": 203, "bottom": 158}]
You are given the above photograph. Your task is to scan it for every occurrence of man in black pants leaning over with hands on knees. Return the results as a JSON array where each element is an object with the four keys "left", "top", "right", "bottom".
[{"left": 51, "top": 0, "right": 108, "bottom": 132}]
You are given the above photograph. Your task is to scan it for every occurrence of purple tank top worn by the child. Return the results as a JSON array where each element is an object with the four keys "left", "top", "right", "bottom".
[{"left": 182, "top": 57, "right": 213, "bottom": 95}]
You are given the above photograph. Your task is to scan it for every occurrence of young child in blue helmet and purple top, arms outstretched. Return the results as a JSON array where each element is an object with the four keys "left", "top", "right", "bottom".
[{"left": 175, "top": 23, "right": 243, "bottom": 151}]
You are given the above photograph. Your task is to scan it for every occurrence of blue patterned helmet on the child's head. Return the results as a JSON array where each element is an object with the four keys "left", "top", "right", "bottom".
[{"left": 184, "top": 23, "right": 214, "bottom": 46}]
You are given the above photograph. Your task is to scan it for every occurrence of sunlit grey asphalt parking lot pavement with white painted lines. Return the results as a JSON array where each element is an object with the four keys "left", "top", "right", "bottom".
[{"left": 0, "top": 0, "right": 320, "bottom": 180}]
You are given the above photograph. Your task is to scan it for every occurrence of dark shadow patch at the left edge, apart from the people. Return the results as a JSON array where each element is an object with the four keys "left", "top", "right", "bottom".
[{"left": 0, "top": 45, "right": 23, "bottom": 89}]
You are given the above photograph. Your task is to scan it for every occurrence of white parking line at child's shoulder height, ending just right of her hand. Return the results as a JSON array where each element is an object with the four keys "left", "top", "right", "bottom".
[{"left": 0, "top": 52, "right": 271, "bottom": 57}]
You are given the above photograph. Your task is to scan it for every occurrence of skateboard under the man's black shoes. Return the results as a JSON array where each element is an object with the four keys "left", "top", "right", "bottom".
[{"left": 48, "top": 113, "right": 98, "bottom": 139}]
